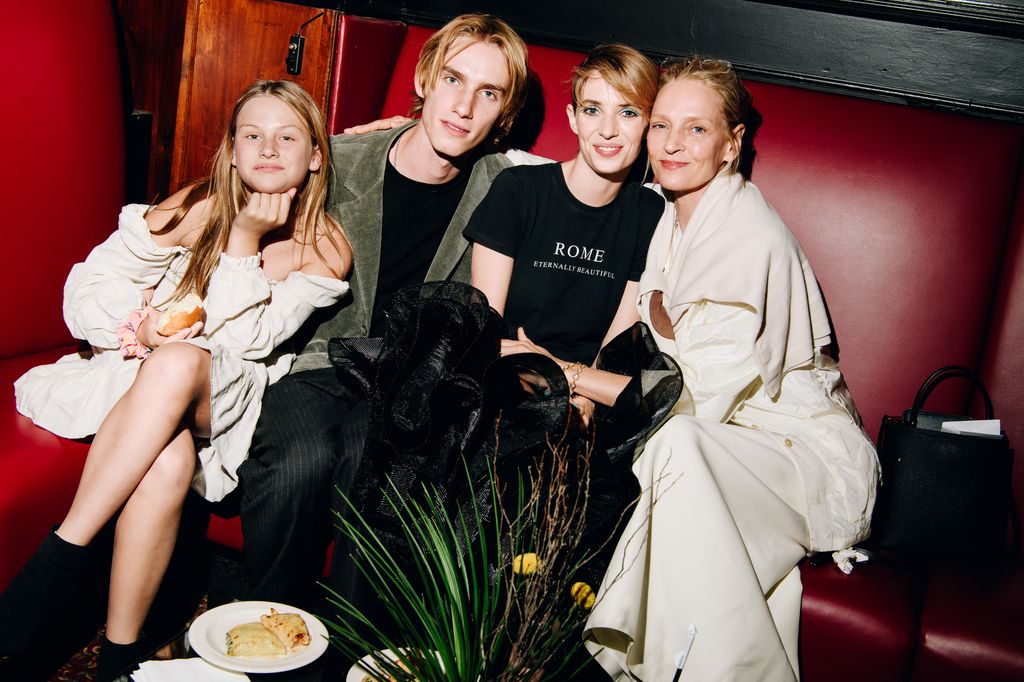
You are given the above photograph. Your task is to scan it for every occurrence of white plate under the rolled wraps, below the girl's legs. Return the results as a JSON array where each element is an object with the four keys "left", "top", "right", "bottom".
[{"left": 188, "top": 601, "right": 328, "bottom": 673}]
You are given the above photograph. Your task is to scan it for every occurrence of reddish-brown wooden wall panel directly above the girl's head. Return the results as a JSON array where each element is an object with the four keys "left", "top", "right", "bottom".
[{"left": 170, "top": 0, "right": 337, "bottom": 190}]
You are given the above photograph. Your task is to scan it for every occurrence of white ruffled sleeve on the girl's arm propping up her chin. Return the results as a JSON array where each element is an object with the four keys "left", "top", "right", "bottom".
[{"left": 204, "top": 254, "right": 348, "bottom": 360}]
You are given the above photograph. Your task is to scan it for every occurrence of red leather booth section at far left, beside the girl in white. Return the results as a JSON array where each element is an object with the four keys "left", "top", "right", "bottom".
[{"left": 0, "top": 0, "right": 125, "bottom": 588}]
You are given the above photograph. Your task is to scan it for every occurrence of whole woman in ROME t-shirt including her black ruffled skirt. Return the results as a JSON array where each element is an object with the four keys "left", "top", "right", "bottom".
[{"left": 323, "top": 45, "right": 682, "bottom": 677}]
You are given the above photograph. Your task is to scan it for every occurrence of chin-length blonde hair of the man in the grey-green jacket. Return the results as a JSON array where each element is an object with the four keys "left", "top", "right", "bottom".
[{"left": 411, "top": 14, "right": 529, "bottom": 141}]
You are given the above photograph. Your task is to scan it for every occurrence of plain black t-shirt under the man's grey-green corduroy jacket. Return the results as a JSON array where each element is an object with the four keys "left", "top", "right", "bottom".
[{"left": 370, "top": 154, "right": 470, "bottom": 336}]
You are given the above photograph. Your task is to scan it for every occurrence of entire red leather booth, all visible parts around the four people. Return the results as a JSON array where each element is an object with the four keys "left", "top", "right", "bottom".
[{"left": 0, "top": 7, "right": 1024, "bottom": 682}]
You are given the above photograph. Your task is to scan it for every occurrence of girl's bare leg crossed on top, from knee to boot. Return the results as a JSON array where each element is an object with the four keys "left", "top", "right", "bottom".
[{"left": 56, "top": 343, "right": 210, "bottom": 545}]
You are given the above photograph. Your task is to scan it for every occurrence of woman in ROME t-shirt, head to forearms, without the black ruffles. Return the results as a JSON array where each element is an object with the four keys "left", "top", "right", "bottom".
[{"left": 464, "top": 45, "right": 665, "bottom": 415}]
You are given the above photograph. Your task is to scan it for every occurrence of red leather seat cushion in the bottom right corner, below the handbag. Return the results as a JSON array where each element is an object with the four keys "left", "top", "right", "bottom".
[{"left": 912, "top": 561, "right": 1024, "bottom": 682}]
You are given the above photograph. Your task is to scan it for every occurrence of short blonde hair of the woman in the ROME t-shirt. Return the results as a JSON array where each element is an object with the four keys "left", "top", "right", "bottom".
[{"left": 572, "top": 43, "right": 658, "bottom": 118}]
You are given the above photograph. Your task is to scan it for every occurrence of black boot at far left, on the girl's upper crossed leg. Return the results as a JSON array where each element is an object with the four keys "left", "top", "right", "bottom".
[{"left": 0, "top": 531, "right": 87, "bottom": 655}]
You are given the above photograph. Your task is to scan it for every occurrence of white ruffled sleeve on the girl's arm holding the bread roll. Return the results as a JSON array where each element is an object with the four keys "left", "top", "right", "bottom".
[{"left": 63, "top": 204, "right": 187, "bottom": 348}]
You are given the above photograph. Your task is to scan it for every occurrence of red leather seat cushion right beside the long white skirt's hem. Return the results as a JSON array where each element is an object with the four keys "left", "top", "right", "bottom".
[{"left": 800, "top": 561, "right": 918, "bottom": 682}]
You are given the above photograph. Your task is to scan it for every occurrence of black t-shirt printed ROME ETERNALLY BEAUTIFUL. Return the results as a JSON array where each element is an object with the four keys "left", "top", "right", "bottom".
[{"left": 463, "top": 164, "right": 665, "bottom": 363}]
